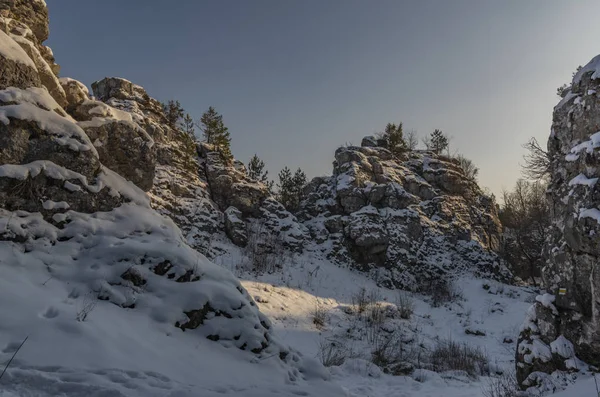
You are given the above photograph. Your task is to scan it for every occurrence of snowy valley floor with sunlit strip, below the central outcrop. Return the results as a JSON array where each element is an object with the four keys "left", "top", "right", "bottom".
[{"left": 226, "top": 251, "right": 536, "bottom": 397}]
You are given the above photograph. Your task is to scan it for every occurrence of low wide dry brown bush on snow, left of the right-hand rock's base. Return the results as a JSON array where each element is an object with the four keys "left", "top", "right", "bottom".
[{"left": 430, "top": 339, "right": 489, "bottom": 376}]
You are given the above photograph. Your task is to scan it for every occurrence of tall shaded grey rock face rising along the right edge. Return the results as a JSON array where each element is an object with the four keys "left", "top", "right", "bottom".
[{"left": 517, "top": 57, "right": 600, "bottom": 387}]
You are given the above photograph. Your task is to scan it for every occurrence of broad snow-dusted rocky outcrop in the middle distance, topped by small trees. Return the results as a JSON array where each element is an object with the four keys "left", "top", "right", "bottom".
[{"left": 298, "top": 141, "right": 510, "bottom": 289}]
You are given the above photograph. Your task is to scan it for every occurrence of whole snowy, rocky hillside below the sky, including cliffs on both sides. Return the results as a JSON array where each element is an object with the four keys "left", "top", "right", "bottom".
[{"left": 0, "top": 0, "right": 600, "bottom": 397}]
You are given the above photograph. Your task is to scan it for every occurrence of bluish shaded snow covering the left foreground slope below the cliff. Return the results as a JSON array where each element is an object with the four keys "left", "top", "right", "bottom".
[{"left": 0, "top": 203, "right": 345, "bottom": 397}]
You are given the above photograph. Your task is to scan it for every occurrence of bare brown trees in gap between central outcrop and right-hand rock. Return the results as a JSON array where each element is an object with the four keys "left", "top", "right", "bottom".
[{"left": 499, "top": 179, "right": 550, "bottom": 285}]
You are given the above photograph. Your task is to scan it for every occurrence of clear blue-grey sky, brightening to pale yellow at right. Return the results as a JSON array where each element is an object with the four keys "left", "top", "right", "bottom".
[{"left": 47, "top": 0, "right": 600, "bottom": 194}]
